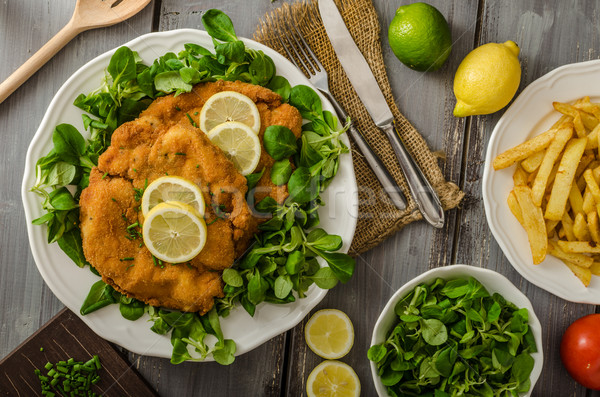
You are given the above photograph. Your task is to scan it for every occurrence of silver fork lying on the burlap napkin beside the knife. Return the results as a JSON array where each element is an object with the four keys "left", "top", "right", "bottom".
[{"left": 276, "top": 15, "right": 406, "bottom": 211}]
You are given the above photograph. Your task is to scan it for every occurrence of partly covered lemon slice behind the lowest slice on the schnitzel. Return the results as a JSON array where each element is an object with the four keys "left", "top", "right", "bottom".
[{"left": 142, "top": 176, "right": 204, "bottom": 217}]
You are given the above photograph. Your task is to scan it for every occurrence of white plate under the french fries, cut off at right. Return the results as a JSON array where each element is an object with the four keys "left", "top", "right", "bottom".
[{"left": 482, "top": 60, "right": 600, "bottom": 304}]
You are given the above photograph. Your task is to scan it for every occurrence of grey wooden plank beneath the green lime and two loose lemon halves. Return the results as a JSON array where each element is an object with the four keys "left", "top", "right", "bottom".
[{"left": 286, "top": 1, "right": 477, "bottom": 396}]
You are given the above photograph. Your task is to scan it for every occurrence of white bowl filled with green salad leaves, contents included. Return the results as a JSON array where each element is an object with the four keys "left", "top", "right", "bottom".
[{"left": 368, "top": 265, "right": 543, "bottom": 397}]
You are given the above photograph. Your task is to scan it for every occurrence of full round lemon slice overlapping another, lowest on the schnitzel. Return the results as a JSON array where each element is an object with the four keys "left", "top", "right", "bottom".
[{"left": 142, "top": 201, "right": 206, "bottom": 263}]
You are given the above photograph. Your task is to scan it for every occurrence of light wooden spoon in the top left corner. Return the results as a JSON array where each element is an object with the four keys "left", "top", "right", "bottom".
[{"left": 0, "top": 0, "right": 150, "bottom": 103}]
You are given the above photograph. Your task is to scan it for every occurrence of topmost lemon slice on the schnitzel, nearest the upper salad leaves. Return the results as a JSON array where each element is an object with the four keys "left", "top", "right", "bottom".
[{"left": 200, "top": 91, "right": 260, "bottom": 134}]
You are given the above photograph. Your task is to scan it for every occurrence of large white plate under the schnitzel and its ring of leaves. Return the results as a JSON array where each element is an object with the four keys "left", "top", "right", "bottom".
[{"left": 21, "top": 29, "right": 358, "bottom": 357}]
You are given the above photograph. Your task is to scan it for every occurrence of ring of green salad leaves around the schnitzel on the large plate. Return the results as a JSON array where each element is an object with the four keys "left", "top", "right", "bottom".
[{"left": 32, "top": 10, "right": 355, "bottom": 365}]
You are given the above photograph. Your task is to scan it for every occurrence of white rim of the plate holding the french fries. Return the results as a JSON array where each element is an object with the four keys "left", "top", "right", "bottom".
[{"left": 482, "top": 59, "right": 600, "bottom": 305}]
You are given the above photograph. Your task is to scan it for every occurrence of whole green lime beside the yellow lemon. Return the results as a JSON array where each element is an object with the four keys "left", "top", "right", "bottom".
[{"left": 388, "top": 3, "right": 452, "bottom": 72}]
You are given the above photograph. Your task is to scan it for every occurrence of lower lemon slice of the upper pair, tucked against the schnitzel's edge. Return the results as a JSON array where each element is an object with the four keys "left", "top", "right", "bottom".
[{"left": 208, "top": 121, "right": 261, "bottom": 175}]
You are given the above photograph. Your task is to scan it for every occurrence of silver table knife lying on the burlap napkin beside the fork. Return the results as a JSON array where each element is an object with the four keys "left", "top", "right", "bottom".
[{"left": 318, "top": 0, "right": 444, "bottom": 228}]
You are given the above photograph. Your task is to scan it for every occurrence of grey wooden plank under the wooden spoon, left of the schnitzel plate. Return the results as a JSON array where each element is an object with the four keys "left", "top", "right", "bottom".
[{"left": 0, "top": 0, "right": 157, "bottom": 357}]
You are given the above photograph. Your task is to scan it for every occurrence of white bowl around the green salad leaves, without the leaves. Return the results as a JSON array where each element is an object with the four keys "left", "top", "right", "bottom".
[{"left": 371, "top": 265, "right": 544, "bottom": 397}]
